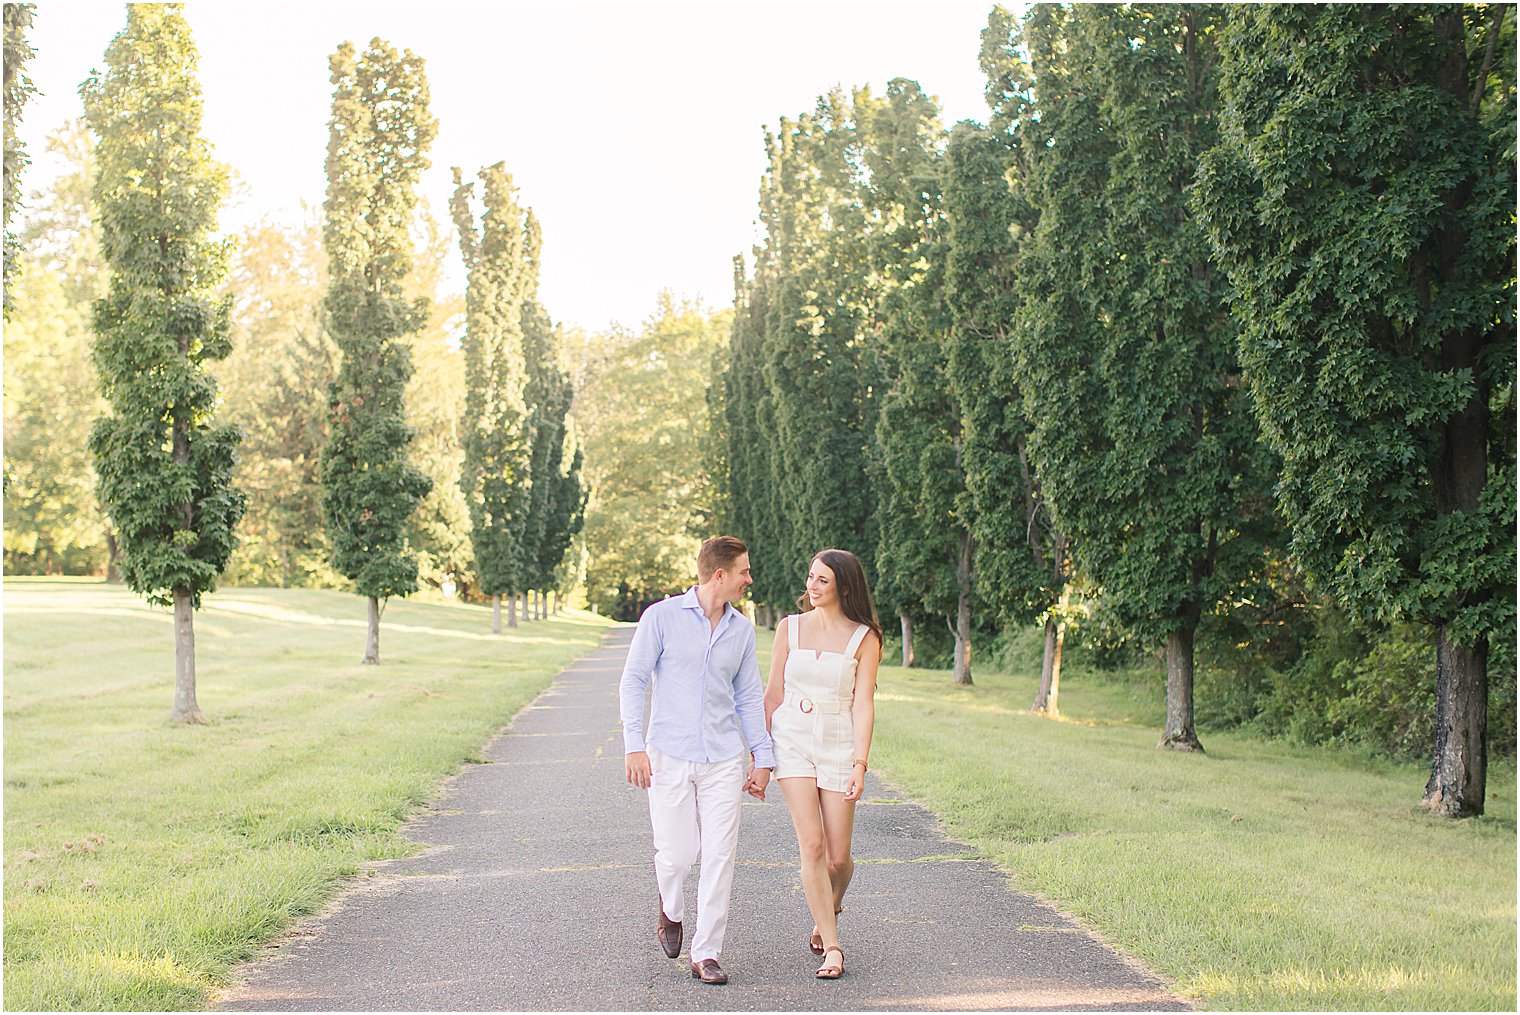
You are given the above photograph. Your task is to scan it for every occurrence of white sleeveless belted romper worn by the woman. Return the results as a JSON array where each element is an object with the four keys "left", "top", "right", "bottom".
[{"left": 771, "top": 614, "right": 869, "bottom": 793}]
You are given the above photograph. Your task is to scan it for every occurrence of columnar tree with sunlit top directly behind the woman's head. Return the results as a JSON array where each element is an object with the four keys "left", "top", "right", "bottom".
[{"left": 731, "top": 90, "right": 880, "bottom": 608}]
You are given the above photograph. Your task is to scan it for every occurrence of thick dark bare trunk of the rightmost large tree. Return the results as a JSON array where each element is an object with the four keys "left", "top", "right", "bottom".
[{"left": 1420, "top": 624, "right": 1488, "bottom": 817}]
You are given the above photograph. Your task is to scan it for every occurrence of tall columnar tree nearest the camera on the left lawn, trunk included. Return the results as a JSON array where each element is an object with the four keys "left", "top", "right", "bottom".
[{"left": 82, "top": 3, "right": 243, "bottom": 722}]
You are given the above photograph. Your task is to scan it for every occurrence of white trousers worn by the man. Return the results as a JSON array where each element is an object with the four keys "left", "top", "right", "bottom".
[{"left": 649, "top": 746, "right": 745, "bottom": 962}]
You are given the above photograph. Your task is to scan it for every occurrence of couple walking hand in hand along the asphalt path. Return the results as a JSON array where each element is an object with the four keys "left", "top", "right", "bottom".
[{"left": 619, "top": 536, "right": 882, "bottom": 983}]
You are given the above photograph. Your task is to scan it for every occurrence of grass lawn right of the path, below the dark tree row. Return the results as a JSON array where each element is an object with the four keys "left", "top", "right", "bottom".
[{"left": 762, "top": 635, "right": 1515, "bottom": 1012}]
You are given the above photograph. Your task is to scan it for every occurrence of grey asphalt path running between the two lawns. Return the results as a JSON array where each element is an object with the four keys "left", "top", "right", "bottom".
[{"left": 216, "top": 626, "right": 1187, "bottom": 1012}]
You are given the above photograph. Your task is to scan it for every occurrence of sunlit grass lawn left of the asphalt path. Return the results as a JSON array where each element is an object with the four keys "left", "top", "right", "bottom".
[{"left": 5, "top": 579, "right": 606, "bottom": 1010}]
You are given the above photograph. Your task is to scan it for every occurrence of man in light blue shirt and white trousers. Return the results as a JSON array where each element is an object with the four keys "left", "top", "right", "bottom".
[{"left": 619, "top": 536, "right": 775, "bottom": 983}]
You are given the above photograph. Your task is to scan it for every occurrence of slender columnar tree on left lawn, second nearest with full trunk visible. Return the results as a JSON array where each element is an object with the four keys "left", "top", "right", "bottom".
[{"left": 322, "top": 38, "right": 438, "bottom": 664}]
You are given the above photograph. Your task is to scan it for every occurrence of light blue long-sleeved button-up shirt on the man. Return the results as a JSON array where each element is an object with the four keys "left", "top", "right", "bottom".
[{"left": 619, "top": 585, "right": 775, "bottom": 769}]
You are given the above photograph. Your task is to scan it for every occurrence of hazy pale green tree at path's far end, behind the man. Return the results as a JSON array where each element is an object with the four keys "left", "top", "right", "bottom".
[{"left": 575, "top": 293, "right": 729, "bottom": 612}]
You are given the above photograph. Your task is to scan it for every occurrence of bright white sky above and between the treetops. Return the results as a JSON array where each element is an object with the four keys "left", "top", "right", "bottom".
[{"left": 21, "top": 0, "right": 993, "bottom": 328}]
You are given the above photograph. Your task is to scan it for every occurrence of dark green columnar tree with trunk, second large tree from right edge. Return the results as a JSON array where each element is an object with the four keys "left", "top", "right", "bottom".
[{"left": 1014, "top": 5, "right": 1271, "bottom": 749}]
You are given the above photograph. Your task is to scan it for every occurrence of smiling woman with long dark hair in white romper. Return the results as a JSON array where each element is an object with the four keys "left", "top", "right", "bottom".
[{"left": 765, "top": 550, "right": 882, "bottom": 980}]
